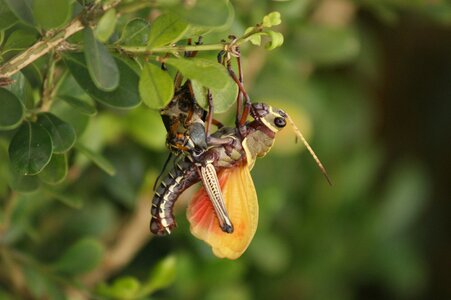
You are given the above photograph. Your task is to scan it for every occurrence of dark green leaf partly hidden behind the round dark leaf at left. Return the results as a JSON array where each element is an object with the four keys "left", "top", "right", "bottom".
[{"left": 38, "top": 113, "right": 76, "bottom": 153}]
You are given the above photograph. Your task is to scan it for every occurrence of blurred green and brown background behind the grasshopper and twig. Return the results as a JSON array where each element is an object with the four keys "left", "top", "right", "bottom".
[{"left": 0, "top": 0, "right": 451, "bottom": 300}]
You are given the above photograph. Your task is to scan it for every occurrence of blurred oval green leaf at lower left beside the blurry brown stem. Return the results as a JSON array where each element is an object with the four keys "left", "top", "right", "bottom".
[{"left": 53, "top": 238, "right": 105, "bottom": 275}]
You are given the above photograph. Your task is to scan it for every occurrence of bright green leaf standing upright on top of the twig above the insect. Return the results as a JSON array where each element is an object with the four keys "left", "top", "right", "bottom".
[{"left": 147, "top": 13, "right": 188, "bottom": 49}]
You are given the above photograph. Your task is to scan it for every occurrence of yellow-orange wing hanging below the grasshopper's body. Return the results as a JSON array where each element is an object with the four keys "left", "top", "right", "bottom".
[{"left": 187, "top": 164, "right": 258, "bottom": 259}]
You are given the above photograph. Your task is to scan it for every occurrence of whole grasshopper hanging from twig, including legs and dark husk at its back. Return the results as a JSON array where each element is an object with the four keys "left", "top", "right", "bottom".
[{"left": 150, "top": 43, "right": 330, "bottom": 259}]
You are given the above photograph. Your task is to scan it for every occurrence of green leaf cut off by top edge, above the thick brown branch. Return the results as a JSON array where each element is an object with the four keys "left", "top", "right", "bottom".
[{"left": 33, "top": 0, "right": 72, "bottom": 29}]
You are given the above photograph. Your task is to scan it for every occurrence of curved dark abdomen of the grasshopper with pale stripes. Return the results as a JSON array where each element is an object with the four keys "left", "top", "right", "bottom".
[{"left": 150, "top": 158, "right": 199, "bottom": 235}]
